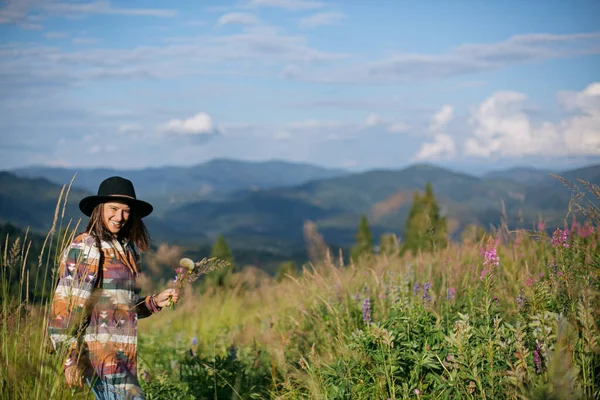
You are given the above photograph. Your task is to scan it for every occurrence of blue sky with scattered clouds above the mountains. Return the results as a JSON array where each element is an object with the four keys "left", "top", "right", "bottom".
[{"left": 0, "top": 0, "right": 600, "bottom": 171}]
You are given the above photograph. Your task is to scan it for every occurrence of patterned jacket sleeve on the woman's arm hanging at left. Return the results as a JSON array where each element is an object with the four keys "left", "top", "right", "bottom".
[{"left": 48, "top": 234, "right": 100, "bottom": 368}]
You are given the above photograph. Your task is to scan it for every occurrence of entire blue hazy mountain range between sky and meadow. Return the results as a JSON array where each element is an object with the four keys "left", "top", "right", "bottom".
[{"left": 0, "top": 159, "right": 600, "bottom": 268}]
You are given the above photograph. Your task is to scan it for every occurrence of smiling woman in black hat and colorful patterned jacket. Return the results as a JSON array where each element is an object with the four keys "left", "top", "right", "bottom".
[{"left": 49, "top": 176, "right": 179, "bottom": 400}]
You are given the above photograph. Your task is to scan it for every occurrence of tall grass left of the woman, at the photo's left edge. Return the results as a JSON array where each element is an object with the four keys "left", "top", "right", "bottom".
[{"left": 0, "top": 181, "right": 90, "bottom": 399}]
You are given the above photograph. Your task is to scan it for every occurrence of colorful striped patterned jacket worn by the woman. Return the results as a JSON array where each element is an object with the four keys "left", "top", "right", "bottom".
[{"left": 48, "top": 233, "right": 159, "bottom": 395}]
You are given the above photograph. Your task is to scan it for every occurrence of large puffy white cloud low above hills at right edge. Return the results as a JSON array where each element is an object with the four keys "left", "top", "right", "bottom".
[{"left": 465, "top": 83, "right": 600, "bottom": 157}]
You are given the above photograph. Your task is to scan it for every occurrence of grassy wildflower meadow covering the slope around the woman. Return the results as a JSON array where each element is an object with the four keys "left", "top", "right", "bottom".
[{"left": 0, "top": 179, "right": 600, "bottom": 400}]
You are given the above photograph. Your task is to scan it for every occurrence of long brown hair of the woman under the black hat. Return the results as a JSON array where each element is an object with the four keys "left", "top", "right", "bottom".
[{"left": 85, "top": 203, "right": 150, "bottom": 251}]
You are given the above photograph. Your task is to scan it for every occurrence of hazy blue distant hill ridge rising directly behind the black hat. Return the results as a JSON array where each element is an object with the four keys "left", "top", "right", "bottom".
[{"left": 10, "top": 159, "right": 347, "bottom": 208}]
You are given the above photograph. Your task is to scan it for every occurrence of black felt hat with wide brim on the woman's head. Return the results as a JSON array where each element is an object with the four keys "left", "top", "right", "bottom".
[{"left": 79, "top": 176, "right": 153, "bottom": 218}]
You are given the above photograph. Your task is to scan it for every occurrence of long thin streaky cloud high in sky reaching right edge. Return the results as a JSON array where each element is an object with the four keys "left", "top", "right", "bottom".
[{"left": 286, "top": 32, "right": 600, "bottom": 84}]
